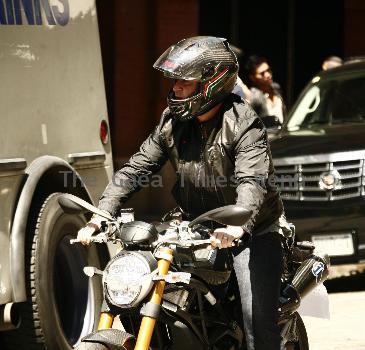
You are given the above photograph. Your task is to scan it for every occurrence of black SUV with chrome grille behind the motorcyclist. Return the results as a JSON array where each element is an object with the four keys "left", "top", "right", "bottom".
[{"left": 271, "top": 60, "right": 365, "bottom": 264}]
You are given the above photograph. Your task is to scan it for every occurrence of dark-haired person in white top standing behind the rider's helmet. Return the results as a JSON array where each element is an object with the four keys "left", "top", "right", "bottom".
[{"left": 245, "top": 55, "right": 286, "bottom": 124}]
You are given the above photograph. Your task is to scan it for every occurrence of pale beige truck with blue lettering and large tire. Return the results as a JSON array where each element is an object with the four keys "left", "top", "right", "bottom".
[{"left": 0, "top": 0, "right": 113, "bottom": 350}]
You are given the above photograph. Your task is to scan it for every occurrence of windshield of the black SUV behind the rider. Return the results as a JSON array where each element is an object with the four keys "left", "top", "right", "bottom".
[{"left": 287, "top": 74, "right": 365, "bottom": 131}]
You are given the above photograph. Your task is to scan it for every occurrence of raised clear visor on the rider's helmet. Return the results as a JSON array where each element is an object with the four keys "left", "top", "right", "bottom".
[{"left": 153, "top": 46, "right": 203, "bottom": 80}]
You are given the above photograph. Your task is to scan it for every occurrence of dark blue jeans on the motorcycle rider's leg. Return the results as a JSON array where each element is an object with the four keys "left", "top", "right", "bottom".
[{"left": 233, "top": 233, "right": 283, "bottom": 350}]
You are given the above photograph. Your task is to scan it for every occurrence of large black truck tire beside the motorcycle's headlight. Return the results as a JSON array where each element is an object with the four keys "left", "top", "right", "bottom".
[{"left": 5, "top": 193, "right": 102, "bottom": 350}]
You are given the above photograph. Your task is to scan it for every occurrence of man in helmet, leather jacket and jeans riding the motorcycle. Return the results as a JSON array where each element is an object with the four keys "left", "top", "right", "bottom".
[{"left": 78, "top": 36, "right": 288, "bottom": 350}]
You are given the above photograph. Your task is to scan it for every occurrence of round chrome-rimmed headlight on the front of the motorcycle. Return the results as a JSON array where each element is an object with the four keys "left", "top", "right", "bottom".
[{"left": 103, "top": 252, "right": 157, "bottom": 308}]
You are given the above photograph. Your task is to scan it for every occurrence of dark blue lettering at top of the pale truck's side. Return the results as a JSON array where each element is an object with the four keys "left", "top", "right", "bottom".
[{"left": 0, "top": 0, "right": 70, "bottom": 26}]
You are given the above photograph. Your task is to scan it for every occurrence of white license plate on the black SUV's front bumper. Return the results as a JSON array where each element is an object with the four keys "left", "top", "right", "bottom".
[{"left": 312, "top": 233, "right": 355, "bottom": 256}]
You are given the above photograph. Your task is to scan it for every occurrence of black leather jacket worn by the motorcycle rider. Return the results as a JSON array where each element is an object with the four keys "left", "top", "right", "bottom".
[{"left": 99, "top": 94, "right": 283, "bottom": 234}]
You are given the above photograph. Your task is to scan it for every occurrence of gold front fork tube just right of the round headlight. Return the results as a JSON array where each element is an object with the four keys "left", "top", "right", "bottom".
[{"left": 134, "top": 247, "right": 173, "bottom": 350}]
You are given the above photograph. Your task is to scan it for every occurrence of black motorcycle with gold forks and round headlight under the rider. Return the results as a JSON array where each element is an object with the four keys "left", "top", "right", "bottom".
[{"left": 59, "top": 194, "right": 329, "bottom": 350}]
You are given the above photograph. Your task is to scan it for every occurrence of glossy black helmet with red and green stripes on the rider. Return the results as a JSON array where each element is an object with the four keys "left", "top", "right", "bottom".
[{"left": 153, "top": 36, "right": 238, "bottom": 121}]
